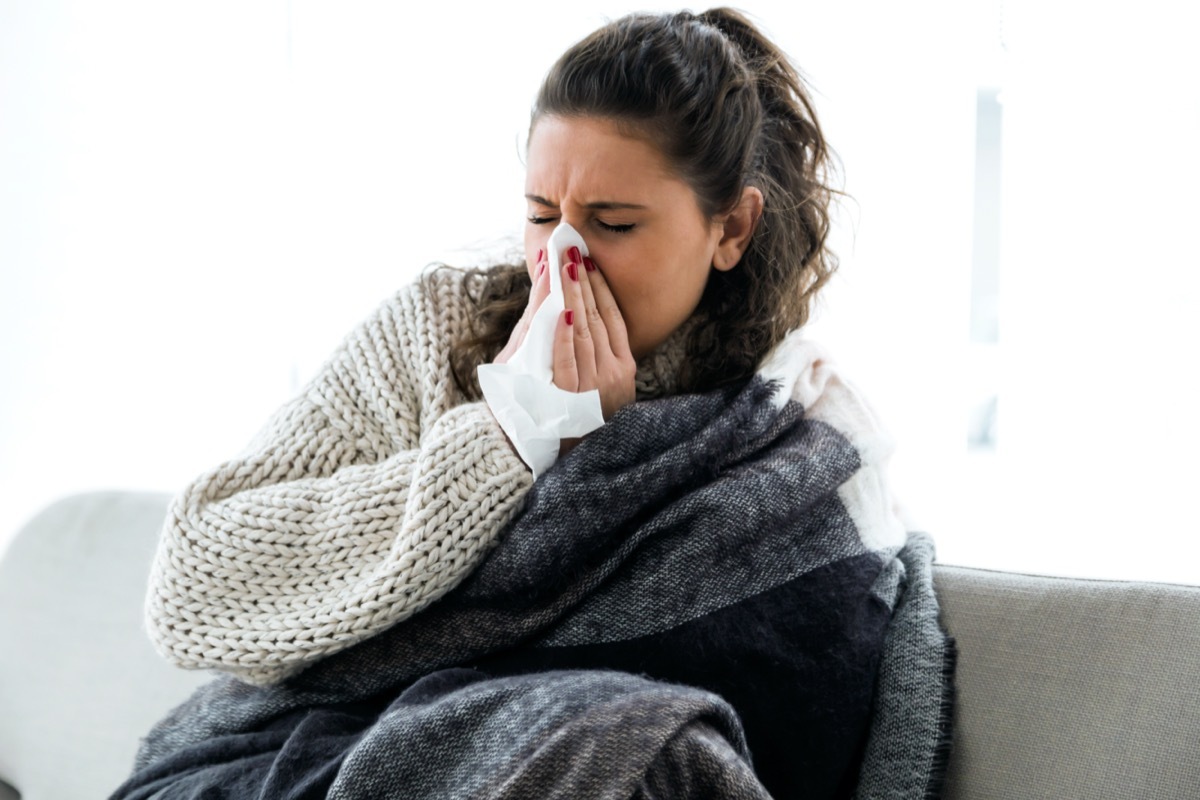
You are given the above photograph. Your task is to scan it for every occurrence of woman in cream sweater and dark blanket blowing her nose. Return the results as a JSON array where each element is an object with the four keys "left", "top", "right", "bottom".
[{"left": 129, "top": 10, "right": 944, "bottom": 796}]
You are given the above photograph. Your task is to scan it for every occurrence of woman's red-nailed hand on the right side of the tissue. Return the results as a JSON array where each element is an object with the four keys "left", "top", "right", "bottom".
[{"left": 554, "top": 247, "right": 637, "bottom": 452}]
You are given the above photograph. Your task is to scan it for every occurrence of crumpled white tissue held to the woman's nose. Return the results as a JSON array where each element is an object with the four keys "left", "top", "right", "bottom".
[{"left": 479, "top": 222, "right": 604, "bottom": 480}]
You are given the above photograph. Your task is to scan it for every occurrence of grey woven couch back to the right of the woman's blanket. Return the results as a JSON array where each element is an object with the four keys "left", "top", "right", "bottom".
[{"left": 935, "top": 566, "right": 1200, "bottom": 800}]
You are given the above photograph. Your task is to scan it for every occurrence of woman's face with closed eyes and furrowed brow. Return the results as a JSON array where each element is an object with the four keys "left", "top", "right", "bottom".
[{"left": 524, "top": 116, "right": 722, "bottom": 357}]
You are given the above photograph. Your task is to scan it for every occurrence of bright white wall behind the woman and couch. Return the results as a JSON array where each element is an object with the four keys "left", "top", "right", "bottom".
[{"left": 0, "top": 0, "right": 1200, "bottom": 583}]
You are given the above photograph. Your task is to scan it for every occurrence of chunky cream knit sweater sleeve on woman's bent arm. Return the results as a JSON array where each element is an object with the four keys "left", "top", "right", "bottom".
[{"left": 146, "top": 278, "right": 533, "bottom": 684}]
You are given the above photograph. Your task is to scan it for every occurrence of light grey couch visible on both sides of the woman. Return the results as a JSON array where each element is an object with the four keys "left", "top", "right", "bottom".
[{"left": 0, "top": 492, "right": 1200, "bottom": 800}]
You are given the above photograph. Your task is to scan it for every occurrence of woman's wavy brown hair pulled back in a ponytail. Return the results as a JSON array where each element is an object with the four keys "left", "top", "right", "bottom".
[{"left": 436, "top": 8, "right": 838, "bottom": 397}]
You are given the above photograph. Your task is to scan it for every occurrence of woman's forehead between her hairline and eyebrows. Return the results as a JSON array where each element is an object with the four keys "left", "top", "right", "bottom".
[{"left": 526, "top": 116, "right": 688, "bottom": 201}]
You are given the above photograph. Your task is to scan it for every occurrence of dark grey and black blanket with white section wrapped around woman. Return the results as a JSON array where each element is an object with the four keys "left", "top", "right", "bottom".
[{"left": 114, "top": 357, "right": 953, "bottom": 800}]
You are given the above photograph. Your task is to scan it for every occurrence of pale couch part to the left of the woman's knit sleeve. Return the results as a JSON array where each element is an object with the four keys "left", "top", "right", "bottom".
[{"left": 0, "top": 492, "right": 208, "bottom": 800}]
